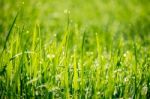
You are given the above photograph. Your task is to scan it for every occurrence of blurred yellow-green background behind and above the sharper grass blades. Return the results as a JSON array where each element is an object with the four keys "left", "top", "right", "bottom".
[{"left": 0, "top": 0, "right": 150, "bottom": 42}]
